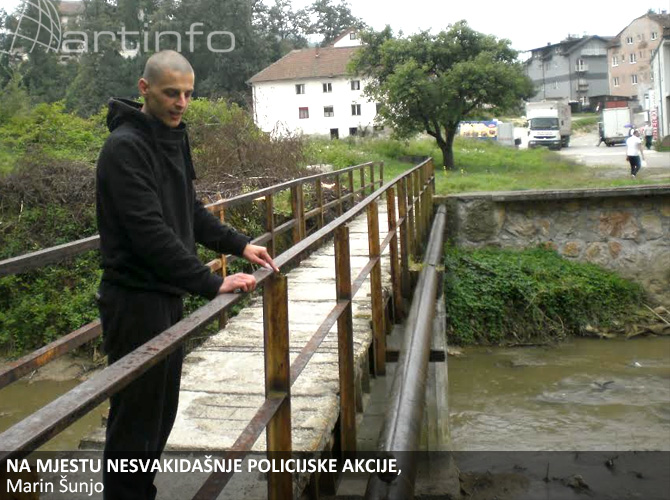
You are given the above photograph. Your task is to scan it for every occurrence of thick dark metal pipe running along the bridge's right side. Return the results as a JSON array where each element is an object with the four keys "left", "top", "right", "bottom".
[{"left": 365, "top": 205, "right": 446, "bottom": 500}]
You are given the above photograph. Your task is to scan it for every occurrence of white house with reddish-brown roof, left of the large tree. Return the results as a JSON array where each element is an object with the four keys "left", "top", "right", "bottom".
[{"left": 249, "top": 30, "right": 381, "bottom": 138}]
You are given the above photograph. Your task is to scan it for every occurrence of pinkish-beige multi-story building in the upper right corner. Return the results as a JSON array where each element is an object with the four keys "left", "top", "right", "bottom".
[{"left": 607, "top": 13, "right": 670, "bottom": 106}]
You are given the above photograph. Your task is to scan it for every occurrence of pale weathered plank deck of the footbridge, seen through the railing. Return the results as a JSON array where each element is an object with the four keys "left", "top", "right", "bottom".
[{"left": 82, "top": 203, "right": 390, "bottom": 458}]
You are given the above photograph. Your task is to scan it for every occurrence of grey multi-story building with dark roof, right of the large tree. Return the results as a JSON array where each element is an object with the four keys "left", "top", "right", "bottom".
[{"left": 526, "top": 36, "right": 611, "bottom": 107}]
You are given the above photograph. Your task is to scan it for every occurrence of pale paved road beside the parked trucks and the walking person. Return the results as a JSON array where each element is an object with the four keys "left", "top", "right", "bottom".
[{"left": 515, "top": 129, "right": 670, "bottom": 182}]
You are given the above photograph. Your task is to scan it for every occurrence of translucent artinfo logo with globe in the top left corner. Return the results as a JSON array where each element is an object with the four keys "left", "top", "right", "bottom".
[{"left": 0, "top": 0, "right": 235, "bottom": 55}]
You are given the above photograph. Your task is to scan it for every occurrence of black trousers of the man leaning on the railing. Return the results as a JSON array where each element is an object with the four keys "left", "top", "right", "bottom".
[{"left": 98, "top": 281, "right": 184, "bottom": 500}]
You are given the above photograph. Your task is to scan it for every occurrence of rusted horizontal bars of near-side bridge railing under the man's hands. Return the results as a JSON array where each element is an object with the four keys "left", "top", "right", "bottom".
[{"left": 0, "top": 157, "right": 434, "bottom": 499}]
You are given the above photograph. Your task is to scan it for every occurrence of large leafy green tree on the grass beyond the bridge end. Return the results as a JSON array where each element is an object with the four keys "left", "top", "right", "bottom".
[{"left": 351, "top": 21, "right": 533, "bottom": 169}]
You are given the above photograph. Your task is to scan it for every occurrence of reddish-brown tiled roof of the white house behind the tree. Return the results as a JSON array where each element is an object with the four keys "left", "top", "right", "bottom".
[{"left": 249, "top": 47, "right": 359, "bottom": 83}]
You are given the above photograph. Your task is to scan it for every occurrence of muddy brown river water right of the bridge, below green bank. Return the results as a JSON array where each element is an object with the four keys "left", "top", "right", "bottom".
[{"left": 449, "top": 337, "right": 670, "bottom": 451}]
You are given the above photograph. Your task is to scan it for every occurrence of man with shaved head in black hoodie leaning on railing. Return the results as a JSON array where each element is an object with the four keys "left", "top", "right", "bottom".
[{"left": 96, "top": 51, "right": 278, "bottom": 500}]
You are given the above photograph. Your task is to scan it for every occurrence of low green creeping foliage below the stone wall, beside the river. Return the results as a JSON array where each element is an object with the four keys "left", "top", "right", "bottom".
[{"left": 444, "top": 247, "right": 642, "bottom": 344}]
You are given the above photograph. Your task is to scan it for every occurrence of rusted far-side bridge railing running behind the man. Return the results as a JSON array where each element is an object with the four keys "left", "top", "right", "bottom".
[{"left": 0, "top": 162, "right": 383, "bottom": 389}]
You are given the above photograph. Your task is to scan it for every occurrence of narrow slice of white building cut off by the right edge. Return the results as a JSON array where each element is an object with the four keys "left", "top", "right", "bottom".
[{"left": 650, "top": 27, "right": 670, "bottom": 139}]
